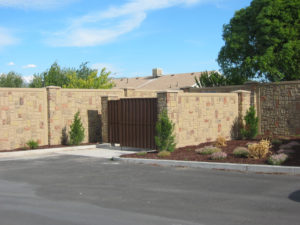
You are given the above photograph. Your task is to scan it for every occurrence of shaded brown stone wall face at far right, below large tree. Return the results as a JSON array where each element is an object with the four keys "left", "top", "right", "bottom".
[{"left": 260, "top": 81, "right": 300, "bottom": 136}]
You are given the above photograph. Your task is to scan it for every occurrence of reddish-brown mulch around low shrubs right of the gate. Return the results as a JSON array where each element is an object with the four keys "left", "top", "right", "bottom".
[{"left": 122, "top": 138, "right": 300, "bottom": 166}]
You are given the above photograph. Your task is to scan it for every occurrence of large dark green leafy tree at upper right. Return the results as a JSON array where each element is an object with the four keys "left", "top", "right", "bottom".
[{"left": 218, "top": 0, "right": 300, "bottom": 83}]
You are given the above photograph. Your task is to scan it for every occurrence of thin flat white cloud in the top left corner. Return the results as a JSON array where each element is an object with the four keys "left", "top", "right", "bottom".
[{"left": 0, "top": 0, "right": 77, "bottom": 9}]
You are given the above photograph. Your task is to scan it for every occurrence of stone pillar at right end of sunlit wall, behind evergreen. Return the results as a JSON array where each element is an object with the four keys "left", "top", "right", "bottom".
[{"left": 232, "top": 90, "right": 251, "bottom": 135}]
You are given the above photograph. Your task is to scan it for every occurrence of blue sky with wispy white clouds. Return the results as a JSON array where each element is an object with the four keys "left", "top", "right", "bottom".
[{"left": 0, "top": 0, "right": 251, "bottom": 81}]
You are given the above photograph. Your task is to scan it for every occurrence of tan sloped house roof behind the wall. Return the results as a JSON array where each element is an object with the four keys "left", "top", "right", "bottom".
[{"left": 113, "top": 72, "right": 205, "bottom": 90}]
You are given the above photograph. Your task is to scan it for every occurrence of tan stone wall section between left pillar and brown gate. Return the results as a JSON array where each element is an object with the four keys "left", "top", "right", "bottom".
[{"left": 49, "top": 87, "right": 124, "bottom": 145}]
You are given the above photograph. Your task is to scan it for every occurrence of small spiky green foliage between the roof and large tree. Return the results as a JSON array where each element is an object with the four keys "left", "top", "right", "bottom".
[{"left": 195, "top": 71, "right": 229, "bottom": 88}]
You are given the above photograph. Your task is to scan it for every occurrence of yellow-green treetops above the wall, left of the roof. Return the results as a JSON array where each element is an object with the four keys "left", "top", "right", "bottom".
[{"left": 29, "top": 62, "right": 113, "bottom": 89}]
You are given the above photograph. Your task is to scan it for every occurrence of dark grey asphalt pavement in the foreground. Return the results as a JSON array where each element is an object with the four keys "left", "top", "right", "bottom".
[{"left": 0, "top": 155, "right": 300, "bottom": 225}]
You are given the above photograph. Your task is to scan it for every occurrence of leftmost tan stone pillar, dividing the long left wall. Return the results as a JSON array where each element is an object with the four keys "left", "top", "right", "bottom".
[{"left": 46, "top": 86, "right": 63, "bottom": 145}]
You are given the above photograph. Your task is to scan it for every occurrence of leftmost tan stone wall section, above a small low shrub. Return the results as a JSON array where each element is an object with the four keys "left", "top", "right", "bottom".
[{"left": 0, "top": 88, "right": 48, "bottom": 150}]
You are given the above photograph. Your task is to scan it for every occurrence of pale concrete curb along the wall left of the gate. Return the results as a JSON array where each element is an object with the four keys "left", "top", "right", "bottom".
[{"left": 0, "top": 145, "right": 97, "bottom": 159}]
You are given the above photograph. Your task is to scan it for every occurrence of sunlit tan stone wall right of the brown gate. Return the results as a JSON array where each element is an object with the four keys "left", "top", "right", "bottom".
[{"left": 158, "top": 92, "right": 243, "bottom": 147}]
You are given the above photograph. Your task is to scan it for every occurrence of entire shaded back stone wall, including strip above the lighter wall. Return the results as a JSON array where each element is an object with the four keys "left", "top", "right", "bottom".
[{"left": 183, "top": 81, "right": 300, "bottom": 136}]
